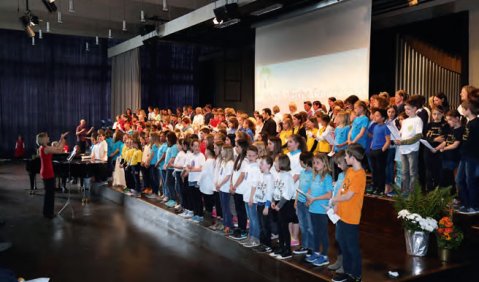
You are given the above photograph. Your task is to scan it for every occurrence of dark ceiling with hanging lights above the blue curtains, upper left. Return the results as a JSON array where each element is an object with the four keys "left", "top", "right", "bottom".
[{"left": 0, "top": 0, "right": 211, "bottom": 39}]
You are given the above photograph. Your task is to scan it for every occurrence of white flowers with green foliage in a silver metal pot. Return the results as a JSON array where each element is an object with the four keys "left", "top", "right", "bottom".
[{"left": 394, "top": 183, "right": 452, "bottom": 256}]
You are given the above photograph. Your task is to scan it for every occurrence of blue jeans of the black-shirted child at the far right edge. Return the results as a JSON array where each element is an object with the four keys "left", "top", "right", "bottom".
[{"left": 456, "top": 160, "right": 479, "bottom": 209}]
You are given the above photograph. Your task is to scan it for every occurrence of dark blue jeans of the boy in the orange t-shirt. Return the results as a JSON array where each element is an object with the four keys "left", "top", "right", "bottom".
[{"left": 336, "top": 220, "right": 361, "bottom": 277}]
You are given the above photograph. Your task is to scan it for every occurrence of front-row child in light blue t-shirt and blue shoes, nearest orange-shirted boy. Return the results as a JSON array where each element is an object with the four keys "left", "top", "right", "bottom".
[{"left": 306, "top": 154, "right": 333, "bottom": 266}]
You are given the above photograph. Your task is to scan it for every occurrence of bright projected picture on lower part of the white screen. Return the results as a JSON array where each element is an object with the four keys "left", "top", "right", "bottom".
[{"left": 255, "top": 48, "right": 369, "bottom": 113}]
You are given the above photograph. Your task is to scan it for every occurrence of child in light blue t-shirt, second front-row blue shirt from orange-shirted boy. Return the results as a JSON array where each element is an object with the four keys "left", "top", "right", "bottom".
[{"left": 293, "top": 152, "right": 314, "bottom": 256}]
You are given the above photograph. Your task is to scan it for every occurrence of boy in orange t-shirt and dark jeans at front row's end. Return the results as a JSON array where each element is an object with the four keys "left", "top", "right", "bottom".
[{"left": 331, "top": 144, "right": 366, "bottom": 282}]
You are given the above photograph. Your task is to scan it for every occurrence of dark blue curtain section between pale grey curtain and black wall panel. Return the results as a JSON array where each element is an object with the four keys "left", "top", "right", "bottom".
[{"left": 140, "top": 41, "right": 200, "bottom": 110}]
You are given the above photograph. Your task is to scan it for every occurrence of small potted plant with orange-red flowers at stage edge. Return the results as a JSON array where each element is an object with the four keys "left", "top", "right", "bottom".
[{"left": 436, "top": 215, "right": 464, "bottom": 262}]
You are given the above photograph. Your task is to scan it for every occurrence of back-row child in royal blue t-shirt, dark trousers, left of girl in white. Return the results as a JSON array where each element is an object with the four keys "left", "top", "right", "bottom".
[{"left": 369, "top": 109, "right": 391, "bottom": 195}]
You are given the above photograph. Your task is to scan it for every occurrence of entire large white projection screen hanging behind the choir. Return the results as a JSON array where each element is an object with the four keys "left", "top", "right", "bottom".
[{"left": 255, "top": 0, "right": 371, "bottom": 113}]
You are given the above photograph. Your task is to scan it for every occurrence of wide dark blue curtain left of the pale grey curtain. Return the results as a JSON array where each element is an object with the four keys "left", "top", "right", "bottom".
[{"left": 0, "top": 30, "right": 111, "bottom": 157}]
